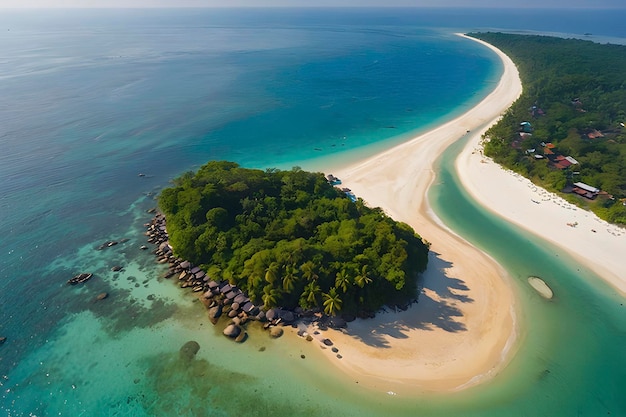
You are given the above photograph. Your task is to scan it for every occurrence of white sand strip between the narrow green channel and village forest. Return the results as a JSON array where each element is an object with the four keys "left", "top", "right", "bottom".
[{"left": 455, "top": 138, "right": 626, "bottom": 296}]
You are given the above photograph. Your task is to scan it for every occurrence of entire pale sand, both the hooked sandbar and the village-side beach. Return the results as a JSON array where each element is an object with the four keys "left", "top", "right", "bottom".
[{"left": 306, "top": 35, "right": 626, "bottom": 395}]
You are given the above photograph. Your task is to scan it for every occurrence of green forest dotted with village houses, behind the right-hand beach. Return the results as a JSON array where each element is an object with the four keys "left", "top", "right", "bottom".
[{"left": 470, "top": 33, "right": 626, "bottom": 225}]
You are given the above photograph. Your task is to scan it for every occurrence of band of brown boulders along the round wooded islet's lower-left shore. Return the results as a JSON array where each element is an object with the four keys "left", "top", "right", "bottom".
[{"left": 145, "top": 213, "right": 316, "bottom": 342}]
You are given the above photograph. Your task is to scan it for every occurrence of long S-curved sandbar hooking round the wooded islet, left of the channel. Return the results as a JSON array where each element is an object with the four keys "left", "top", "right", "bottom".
[{"left": 308, "top": 33, "right": 522, "bottom": 394}]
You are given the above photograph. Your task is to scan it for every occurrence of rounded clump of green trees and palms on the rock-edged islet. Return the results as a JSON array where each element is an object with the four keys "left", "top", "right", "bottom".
[{"left": 159, "top": 161, "right": 428, "bottom": 315}]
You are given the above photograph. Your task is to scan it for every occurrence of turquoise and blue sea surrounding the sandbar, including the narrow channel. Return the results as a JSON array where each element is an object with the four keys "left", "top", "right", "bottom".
[{"left": 0, "top": 9, "right": 626, "bottom": 416}]
